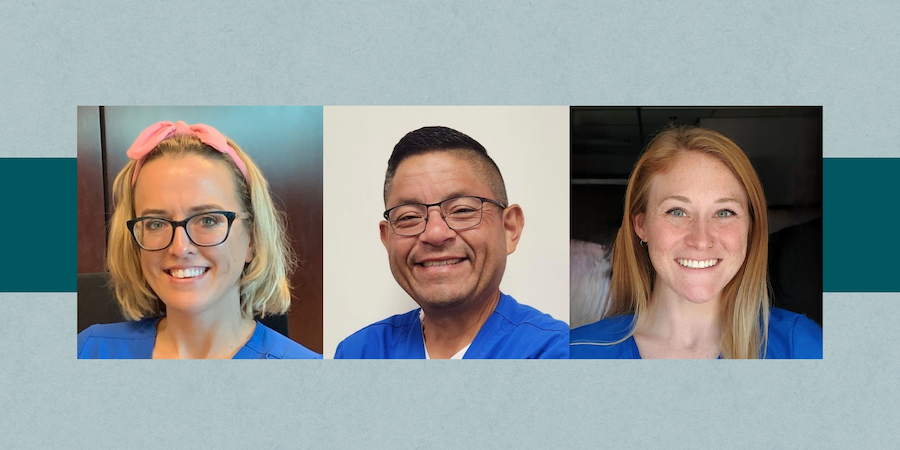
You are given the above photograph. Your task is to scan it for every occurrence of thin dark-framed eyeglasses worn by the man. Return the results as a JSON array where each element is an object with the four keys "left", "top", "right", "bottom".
[{"left": 384, "top": 196, "right": 506, "bottom": 236}]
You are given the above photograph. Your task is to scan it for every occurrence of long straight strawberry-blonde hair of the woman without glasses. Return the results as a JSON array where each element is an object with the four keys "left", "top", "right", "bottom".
[{"left": 607, "top": 126, "right": 769, "bottom": 359}]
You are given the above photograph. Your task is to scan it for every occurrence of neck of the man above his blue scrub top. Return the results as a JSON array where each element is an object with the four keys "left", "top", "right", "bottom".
[{"left": 422, "top": 290, "right": 500, "bottom": 359}]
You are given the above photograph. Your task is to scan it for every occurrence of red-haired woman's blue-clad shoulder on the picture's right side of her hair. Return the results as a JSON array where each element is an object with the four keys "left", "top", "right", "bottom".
[{"left": 766, "top": 308, "right": 822, "bottom": 359}]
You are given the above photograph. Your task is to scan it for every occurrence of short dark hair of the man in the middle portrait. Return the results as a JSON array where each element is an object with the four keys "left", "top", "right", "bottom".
[{"left": 384, "top": 127, "right": 509, "bottom": 206}]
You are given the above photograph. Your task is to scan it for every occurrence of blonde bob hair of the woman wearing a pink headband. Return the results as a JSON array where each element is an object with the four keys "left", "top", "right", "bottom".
[{"left": 106, "top": 136, "right": 294, "bottom": 320}]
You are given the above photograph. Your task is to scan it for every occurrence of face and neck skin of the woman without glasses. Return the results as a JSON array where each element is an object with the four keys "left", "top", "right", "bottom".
[{"left": 633, "top": 152, "right": 750, "bottom": 358}]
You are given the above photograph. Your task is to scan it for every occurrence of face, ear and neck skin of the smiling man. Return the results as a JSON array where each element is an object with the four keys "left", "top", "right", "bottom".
[{"left": 379, "top": 152, "right": 525, "bottom": 358}]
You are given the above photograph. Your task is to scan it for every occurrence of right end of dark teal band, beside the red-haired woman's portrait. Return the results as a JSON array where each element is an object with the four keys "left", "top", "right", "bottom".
[{"left": 824, "top": 158, "right": 900, "bottom": 292}]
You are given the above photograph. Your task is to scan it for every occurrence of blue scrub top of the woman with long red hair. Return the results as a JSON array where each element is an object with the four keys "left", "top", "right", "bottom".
[{"left": 569, "top": 308, "right": 822, "bottom": 359}]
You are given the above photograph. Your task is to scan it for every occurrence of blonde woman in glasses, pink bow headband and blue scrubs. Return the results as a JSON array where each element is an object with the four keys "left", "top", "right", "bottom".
[{"left": 78, "top": 122, "right": 322, "bottom": 359}]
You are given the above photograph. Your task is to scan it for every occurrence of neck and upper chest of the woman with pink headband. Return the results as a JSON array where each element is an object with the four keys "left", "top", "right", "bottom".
[{"left": 153, "top": 303, "right": 256, "bottom": 359}]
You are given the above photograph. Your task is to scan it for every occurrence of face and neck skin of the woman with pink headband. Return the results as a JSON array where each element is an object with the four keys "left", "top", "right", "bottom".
[{"left": 134, "top": 155, "right": 256, "bottom": 358}]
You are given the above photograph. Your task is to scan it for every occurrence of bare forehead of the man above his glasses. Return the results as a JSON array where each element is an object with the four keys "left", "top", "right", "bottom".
[{"left": 387, "top": 151, "right": 491, "bottom": 207}]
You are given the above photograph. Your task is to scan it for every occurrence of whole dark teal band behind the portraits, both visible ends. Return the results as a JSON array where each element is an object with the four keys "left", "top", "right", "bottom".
[{"left": 0, "top": 158, "right": 884, "bottom": 292}]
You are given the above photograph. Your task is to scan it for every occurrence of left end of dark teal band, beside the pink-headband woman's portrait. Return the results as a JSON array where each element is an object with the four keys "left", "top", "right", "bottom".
[{"left": 0, "top": 158, "right": 78, "bottom": 292}]
